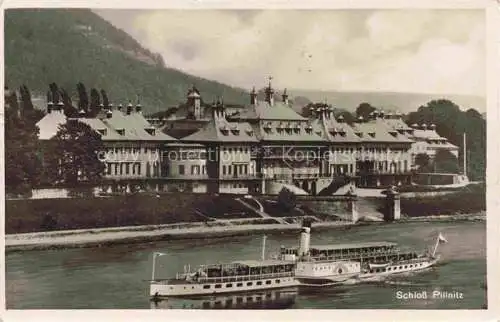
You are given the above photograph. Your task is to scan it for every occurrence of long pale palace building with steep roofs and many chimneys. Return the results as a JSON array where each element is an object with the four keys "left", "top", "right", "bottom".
[{"left": 37, "top": 82, "right": 458, "bottom": 194}]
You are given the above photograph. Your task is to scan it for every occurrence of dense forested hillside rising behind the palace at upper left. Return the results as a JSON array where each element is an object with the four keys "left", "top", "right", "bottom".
[{"left": 4, "top": 9, "right": 248, "bottom": 113}]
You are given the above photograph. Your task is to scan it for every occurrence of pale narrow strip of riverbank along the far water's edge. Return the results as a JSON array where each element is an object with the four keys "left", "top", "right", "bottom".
[{"left": 5, "top": 212, "right": 486, "bottom": 253}]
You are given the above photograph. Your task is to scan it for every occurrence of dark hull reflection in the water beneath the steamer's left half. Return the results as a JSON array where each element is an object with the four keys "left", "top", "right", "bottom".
[{"left": 151, "top": 287, "right": 298, "bottom": 310}]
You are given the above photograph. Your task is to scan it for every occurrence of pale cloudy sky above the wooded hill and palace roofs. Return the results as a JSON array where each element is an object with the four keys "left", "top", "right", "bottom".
[{"left": 97, "top": 9, "right": 486, "bottom": 97}]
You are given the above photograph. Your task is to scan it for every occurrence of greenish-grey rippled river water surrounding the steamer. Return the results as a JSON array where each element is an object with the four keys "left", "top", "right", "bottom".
[{"left": 5, "top": 222, "right": 486, "bottom": 309}]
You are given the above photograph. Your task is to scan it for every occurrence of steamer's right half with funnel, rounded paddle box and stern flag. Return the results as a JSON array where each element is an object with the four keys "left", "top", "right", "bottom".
[{"left": 277, "top": 222, "right": 446, "bottom": 286}]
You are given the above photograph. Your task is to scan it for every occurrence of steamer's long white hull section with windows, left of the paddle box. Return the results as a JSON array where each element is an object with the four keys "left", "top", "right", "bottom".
[{"left": 149, "top": 276, "right": 298, "bottom": 297}]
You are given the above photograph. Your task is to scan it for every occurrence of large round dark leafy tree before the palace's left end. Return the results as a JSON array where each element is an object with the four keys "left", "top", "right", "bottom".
[{"left": 48, "top": 120, "right": 104, "bottom": 187}]
